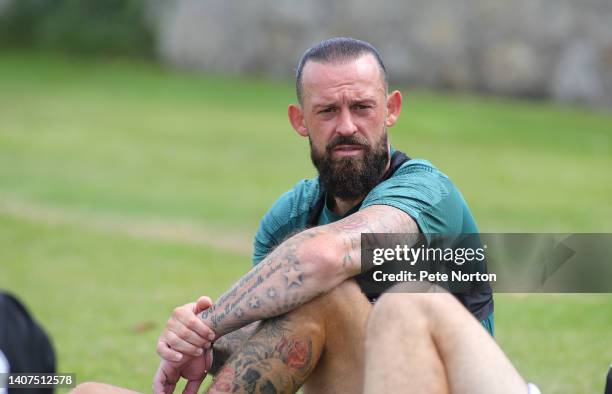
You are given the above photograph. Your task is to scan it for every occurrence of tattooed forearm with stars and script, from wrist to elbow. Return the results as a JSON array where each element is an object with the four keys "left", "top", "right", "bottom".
[{"left": 201, "top": 228, "right": 359, "bottom": 337}]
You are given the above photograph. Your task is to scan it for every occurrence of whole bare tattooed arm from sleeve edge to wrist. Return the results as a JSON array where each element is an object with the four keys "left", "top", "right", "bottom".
[{"left": 200, "top": 205, "right": 418, "bottom": 338}]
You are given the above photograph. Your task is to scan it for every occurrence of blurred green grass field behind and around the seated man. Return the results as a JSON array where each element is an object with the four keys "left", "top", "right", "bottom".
[{"left": 0, "top": 52, "right": 612, "bottom": 393}]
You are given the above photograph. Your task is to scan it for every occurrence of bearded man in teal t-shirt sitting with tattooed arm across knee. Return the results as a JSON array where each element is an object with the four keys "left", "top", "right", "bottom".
[{"left": 71, "top": 38, "right": 512, "bottom": 393}]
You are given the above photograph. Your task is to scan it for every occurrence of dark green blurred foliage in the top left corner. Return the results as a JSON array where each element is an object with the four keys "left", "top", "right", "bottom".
[{"left": 0, "top": 0, "right": 153, "bottom": 57}]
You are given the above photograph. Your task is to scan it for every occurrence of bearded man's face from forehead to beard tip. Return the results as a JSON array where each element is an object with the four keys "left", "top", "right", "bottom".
[{"left": 298, "top": 54, "right": 396, "bottom": 199}]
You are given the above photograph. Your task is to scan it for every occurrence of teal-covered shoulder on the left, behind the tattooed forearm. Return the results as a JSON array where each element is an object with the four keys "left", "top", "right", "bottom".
[{"left": 253, "top": 178, "right": 320, "bottom": 263}]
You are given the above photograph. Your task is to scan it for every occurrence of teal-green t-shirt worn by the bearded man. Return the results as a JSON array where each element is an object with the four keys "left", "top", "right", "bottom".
[{"left": 253, "top": 155, "right": 493, "bottom": 320}]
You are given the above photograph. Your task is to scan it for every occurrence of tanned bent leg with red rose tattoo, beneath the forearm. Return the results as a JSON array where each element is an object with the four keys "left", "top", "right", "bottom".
[{"left": 209, "top": 281, "right": 371, "bottom": 393}]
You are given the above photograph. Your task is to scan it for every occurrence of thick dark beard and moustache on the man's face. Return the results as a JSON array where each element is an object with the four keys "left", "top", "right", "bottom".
[{"left": 310, "top": 131, "right": 389, "bottom": 200}]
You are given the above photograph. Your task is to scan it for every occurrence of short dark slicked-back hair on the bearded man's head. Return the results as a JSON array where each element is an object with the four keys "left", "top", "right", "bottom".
[{"left": 295, "top": 37, "right": 387, "bottom": 104}]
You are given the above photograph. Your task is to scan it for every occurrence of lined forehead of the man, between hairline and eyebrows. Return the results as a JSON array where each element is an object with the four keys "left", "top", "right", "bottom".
[{"left": 302, "top": 54, "right": 385, "bottom": 101}]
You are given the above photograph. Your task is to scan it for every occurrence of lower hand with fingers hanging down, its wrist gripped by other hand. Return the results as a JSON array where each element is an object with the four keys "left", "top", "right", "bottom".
[{"left": 153, "top": 349, "right": 213, "bottom": 394}]
